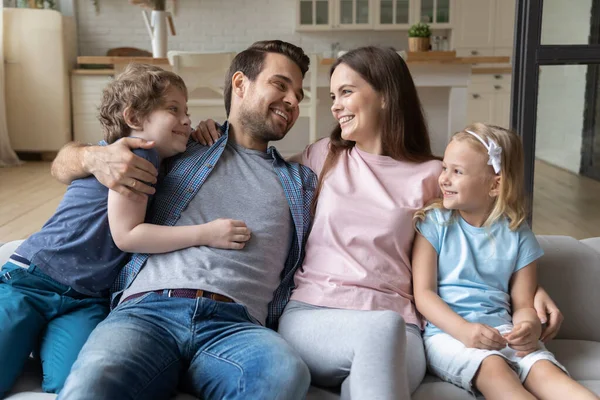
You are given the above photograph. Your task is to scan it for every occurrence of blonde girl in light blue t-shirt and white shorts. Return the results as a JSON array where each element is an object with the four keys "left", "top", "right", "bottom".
[{"left": 412, "top": 124, "right": 598, "bottom": 399}]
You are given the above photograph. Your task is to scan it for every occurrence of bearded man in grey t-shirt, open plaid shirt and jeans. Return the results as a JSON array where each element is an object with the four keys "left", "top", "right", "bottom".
[{"left": 53, "top": 41, "right": 316, "bottom": 399}]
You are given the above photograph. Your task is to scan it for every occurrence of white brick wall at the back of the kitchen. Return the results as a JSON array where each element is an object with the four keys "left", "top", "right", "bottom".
[{"left": 75, "top": 0, "right": 408, "bottom": 56}]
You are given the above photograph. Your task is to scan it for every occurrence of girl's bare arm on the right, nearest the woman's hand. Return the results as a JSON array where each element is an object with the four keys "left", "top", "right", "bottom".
[{"left": 504, "top": 261, "right": 542, "bottom": 356}]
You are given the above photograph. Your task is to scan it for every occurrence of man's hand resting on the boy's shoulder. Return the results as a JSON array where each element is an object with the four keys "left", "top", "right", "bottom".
[{"left": 83, "top": 137, "right": 158, "bottom": 200}]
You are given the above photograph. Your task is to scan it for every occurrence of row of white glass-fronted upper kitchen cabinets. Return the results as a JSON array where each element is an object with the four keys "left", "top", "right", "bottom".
[{"left": 296, "top": 0, "right": 450, "bottom": 31}]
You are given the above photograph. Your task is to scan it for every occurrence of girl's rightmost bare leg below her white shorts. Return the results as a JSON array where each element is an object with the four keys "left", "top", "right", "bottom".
[{"left": 524, "top": 360, "right": 600, "bottom": 400}]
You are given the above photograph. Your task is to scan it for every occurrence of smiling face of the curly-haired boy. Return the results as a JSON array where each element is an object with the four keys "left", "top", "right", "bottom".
[{"left": 141, "top": 87, "right": 192, "bottom": 159}]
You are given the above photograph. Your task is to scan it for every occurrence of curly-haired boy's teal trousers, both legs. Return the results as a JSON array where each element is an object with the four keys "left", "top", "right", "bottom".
[{"left": 0, "top": 262, "right": 109, "bottom": 398}]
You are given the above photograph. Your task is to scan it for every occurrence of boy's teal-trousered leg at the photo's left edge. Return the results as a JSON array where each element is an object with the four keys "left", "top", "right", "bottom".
[{"left": 0, "top": 267, "right": 46, "bottom": 398}]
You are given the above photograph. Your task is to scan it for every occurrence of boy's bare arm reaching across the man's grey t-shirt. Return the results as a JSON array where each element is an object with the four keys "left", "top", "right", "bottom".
[{"left": 108, "top": 190, "right": 250, "bottom": 254}]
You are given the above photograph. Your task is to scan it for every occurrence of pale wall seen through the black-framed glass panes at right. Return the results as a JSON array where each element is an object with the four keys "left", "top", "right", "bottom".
[{"left": 535, "top": 0, "right": 592, "bottom": 173}]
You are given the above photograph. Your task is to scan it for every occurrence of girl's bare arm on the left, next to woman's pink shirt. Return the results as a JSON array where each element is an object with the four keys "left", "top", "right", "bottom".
[{"left": 412, "top": 233, "right": 506, "bottom": 349}]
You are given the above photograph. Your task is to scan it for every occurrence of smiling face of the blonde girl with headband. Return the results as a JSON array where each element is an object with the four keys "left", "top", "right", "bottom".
[{"left": 438, "top": 140, "right": 500, "bottom": 226}]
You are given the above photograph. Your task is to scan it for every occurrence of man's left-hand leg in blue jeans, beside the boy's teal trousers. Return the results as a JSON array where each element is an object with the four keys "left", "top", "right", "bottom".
[{"left": 58, "top": 293, "right": 184, "bottom": 400}]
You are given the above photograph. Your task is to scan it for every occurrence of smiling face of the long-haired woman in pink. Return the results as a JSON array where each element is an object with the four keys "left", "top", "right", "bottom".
[{"left": 330, "top": 63, "right": 384, "bottom": 152}]
